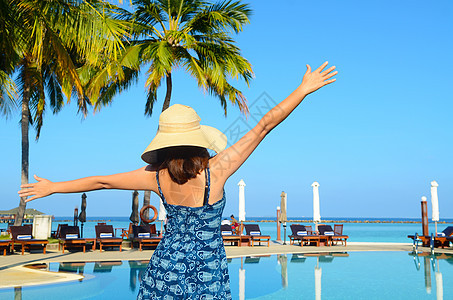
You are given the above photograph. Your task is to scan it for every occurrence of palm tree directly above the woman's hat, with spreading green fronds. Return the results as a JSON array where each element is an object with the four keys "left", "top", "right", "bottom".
[{"left": 126, "top": 0, "right": 253, "bottom": 219}]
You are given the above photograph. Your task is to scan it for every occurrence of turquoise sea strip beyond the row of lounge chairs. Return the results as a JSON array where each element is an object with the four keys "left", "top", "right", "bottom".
[{"left": 0, "top": 217, "right": 453, "bottom": 243}]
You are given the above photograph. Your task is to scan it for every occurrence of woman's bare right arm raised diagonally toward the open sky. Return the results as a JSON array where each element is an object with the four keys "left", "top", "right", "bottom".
[{"left": 211, "top": 62, "right": 337, "bottom": 180}]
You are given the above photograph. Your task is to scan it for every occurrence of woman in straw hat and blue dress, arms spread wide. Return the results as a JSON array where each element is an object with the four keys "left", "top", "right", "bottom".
[{"left": 19, "top": 62, "right": 337, "bottom": 299}]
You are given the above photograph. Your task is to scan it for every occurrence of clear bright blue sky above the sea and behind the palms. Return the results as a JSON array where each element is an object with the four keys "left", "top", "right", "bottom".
[{"left": 0, "top": 0, "right": 453, "bottom": 218}]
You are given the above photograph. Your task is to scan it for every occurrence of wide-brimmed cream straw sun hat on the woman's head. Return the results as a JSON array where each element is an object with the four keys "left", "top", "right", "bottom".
[{"left": 142, "top": 104, "right": 227, "bottom": 164}]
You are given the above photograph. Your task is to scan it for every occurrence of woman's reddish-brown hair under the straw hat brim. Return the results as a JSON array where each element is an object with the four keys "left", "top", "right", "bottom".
[{"left": 159, "top": 146, "right": 209, "bottom": 184}]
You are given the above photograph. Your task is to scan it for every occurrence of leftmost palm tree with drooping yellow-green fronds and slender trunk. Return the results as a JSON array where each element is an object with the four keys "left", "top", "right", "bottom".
[{"left": 3, "top": 0, "right": 130, "bottom": 225}]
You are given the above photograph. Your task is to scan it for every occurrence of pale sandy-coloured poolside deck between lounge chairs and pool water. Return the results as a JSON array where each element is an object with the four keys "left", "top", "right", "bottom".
[{"left": 0, "top": 241, "right": 453, "bottom": 288}]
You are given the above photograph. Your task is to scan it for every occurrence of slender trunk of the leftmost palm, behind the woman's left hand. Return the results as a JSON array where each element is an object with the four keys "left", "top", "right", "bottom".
[{"left": 14, "top": 63, "right": 30, "bottom": 226}]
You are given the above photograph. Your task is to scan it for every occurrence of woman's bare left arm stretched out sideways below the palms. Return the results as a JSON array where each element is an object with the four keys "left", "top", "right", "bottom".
[{"left": 19, "top": 166, "right": 157, "bottom": 202}]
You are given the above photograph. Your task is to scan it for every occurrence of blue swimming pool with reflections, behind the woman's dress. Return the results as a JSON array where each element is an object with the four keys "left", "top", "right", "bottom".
[{"left": 0, "top": 252, "right": 453, "bottom": 300}]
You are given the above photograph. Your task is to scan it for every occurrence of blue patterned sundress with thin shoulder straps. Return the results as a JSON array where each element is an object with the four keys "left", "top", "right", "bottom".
[{"left": 137, "top": 168, "right": 231, "bottom": 300}]
